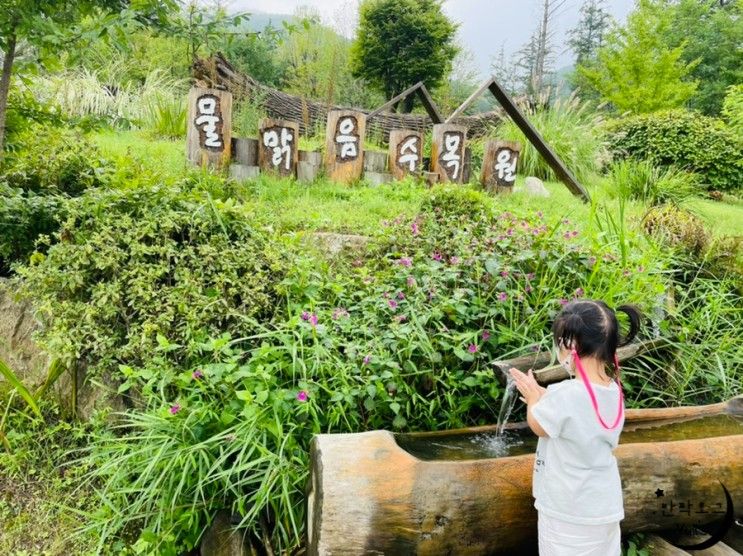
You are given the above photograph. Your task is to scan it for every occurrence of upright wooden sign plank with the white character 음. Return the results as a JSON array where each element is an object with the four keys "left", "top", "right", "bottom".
[{"left": 325, "top": 110, "right": 366, "bottom": 183}]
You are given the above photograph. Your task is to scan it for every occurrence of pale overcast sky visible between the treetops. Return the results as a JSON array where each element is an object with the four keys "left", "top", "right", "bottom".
[{"left": 230, "top": 0, "right": 634, "bottom": 77}]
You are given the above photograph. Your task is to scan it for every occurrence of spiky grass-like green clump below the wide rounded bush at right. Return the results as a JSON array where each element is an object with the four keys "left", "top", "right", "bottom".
[{"left": 609, "top": 159, "right": 697, "bottom": 205}]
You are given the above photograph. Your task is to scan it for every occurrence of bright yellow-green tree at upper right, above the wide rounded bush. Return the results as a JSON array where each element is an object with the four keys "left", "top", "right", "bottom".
[{"left": 577, "top": 0, "right": 697, "bottom": 113}]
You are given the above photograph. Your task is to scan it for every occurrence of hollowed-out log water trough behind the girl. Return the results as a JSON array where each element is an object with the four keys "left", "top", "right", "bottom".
[{"left": 307, "top": 397, "right": 743, "bottom": 555}]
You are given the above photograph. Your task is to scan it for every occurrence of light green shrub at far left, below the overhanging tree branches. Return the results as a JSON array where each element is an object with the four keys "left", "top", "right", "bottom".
[{"left": 0, "top": 125, "right": 109, "bottom": 195}]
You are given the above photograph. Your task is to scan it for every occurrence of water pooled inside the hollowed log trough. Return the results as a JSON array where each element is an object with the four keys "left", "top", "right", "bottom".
[{"left": 396, "top": 412, "right": 743, "bottom": 461}]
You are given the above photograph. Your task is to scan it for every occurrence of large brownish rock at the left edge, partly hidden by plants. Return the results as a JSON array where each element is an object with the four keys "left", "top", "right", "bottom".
[{"left": 0, "top": 278, "right": 49, "bottom": 386}]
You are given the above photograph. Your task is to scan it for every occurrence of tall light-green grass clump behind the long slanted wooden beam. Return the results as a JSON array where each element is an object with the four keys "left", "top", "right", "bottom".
[{"left": 491, "top": 95, "right": 606, "bottom": 181}]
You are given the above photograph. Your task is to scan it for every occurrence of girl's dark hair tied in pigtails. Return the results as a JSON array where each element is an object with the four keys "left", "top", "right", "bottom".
[{"left": 552, "top": 299, "right": 642, "bottom": 374}]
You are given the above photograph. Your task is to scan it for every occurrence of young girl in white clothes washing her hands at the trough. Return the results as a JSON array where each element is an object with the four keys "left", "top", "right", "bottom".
[{"left": 511, "top": 300, "right": 640, "bottom": 556}]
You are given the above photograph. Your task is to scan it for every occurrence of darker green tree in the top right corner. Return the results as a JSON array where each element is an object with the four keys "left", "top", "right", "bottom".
[{"left": 663, "top": 0, "right": 743, "bottom": 115}]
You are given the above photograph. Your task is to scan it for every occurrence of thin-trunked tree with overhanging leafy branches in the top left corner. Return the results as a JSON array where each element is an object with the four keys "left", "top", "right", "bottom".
[{"left": 0, "top": 0, "right": 177, "bottom": 158}]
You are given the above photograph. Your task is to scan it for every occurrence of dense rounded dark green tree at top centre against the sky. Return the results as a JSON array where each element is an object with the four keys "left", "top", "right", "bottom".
[{"left": 351, "top": 0, "right": 457, "bottom": 112}]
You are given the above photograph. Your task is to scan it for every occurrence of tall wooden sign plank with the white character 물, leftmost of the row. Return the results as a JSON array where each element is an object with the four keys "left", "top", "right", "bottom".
[{"left": 186, "top": 87, "right": 232, "bottom": 168}]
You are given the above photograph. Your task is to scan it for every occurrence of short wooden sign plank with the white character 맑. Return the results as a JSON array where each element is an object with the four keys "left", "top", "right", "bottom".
[{"left": 258, "top": 118, "right": 299, "bottom": 177}]
